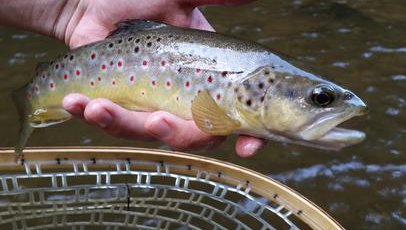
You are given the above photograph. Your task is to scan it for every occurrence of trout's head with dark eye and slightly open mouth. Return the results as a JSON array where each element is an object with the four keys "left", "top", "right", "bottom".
[{"left": 241, "top": 65, "right": 367, "bottom": 149}]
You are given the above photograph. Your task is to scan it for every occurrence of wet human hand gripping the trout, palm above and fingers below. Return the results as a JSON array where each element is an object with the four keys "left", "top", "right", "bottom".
[{"left": 58, "top": 0, "right": 263, "bottom": 157}]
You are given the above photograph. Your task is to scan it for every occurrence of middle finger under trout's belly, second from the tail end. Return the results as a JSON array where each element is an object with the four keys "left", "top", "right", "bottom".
[{"left": 84, "top": 98, "right": 151, "bottom": 140}]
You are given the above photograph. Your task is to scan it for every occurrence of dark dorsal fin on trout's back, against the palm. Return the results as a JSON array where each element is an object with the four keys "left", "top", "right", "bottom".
[{"left": 107, "top": 19, "right": 168, "bottom": 38}]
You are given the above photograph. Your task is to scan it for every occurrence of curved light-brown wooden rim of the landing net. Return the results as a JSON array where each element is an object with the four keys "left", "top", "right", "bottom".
[{"left": 0, "top": 146, "right": 344, "bottom": 229}]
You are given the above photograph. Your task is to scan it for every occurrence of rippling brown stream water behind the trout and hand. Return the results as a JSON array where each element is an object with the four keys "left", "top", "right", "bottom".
[{"left": 0, "top": 0, "right": 406, "bottom": 229}]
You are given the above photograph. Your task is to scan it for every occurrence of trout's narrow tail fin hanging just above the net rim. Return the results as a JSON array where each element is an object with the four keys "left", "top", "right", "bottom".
[{"left": 11, "top": 85, "right": 34, "bottom": 157}]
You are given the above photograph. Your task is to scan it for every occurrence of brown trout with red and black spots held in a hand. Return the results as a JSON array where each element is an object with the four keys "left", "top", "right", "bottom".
[{"left": 14, "top": 20, "right": 366, "bottom": 152}]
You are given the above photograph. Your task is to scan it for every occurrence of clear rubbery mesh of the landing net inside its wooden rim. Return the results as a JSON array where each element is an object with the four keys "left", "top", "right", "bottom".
[{"left": 0, "top": 148, "right": 342, "bottom": 230}]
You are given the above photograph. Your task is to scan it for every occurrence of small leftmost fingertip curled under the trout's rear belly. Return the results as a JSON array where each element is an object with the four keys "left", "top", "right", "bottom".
[{"left": 62, "top": 93, "right": 90, "bottom": 119}]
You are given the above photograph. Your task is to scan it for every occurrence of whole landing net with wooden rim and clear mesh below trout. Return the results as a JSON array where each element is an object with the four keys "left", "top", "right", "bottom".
[{"left": 0, "top": 148, "right": 342, "bottom": 230}]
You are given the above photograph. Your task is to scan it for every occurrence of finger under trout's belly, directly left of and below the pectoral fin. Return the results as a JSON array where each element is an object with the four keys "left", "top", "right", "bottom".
[{"left": 145, "top": 111, "right": 225, "bottom": 150}]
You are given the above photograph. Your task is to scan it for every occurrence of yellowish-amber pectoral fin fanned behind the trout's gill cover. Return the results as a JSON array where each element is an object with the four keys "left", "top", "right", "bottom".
[{"left": 192, "top": 90, "right": 240, "bottom": 136}]
